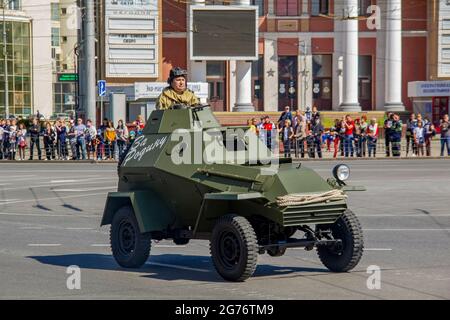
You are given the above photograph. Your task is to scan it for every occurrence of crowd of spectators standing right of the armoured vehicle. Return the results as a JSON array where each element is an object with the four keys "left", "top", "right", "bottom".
[{"left": 248, "top": 107, "right": 450, "bottom": 158}]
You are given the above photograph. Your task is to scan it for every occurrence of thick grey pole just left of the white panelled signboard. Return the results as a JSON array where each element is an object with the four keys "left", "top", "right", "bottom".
[{"left": 84, "top": 0, "right": 97, "bottom": 123}]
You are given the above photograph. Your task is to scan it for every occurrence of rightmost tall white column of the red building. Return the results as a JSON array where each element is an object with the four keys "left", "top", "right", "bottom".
[{"left": 384, "top": 0, "right": 405, "bottom": 111}]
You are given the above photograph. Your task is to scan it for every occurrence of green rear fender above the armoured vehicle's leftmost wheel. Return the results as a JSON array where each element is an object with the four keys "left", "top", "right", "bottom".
[{"left": 101, "top": 190, "right": 175, "bottom": 233}]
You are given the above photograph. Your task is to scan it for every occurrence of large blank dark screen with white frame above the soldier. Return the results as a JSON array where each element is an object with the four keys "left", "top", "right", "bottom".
[{"left": 189, "top": 6, "right": 258, "bottom": 60}]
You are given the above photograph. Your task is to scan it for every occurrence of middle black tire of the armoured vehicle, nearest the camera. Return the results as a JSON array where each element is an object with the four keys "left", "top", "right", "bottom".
[{"left": 210, "top": 215, "right": 258, "bottom": 281}]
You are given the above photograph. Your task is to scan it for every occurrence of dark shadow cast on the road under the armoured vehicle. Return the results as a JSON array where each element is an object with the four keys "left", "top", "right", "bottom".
[{"left": 28, "top": 253, "right": 328, "bottom": 282}]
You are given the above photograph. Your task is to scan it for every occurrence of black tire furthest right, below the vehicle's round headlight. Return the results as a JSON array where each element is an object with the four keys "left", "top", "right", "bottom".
[{"left": 317, "top": 210, "right": 364, "bottom": 272}]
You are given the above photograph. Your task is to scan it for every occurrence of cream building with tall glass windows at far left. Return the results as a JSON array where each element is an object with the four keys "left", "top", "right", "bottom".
[{"left": 0, "top": 0, "right": 79, "bottom": 117}]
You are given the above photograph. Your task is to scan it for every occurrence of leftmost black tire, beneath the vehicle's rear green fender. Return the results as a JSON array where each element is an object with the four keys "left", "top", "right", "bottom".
[{"left": 110, "top": 206, "right": 152, "bottom": 268}]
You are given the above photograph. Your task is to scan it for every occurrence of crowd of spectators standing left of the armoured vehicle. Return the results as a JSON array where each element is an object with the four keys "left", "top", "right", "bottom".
[{"left": 0, "top": 116, "right": 145, "bottom": 161}]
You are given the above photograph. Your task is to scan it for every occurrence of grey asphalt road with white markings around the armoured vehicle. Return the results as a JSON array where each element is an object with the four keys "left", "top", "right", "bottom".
[{"left": 0, "top": 159, "right": 450, "bottom": 299}]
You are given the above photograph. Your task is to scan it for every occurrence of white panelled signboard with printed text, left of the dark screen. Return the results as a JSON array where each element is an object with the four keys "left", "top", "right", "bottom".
[{"left": 105, "top": 0, "right": 159, "bottom": 78}]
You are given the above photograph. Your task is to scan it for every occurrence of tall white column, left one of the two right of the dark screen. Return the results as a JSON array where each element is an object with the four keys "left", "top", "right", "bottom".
[{"left": 340, "top": 0, "right": 361, "bottom": 112}]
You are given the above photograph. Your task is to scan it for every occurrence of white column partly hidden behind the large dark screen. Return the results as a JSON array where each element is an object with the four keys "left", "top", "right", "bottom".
[{"left": 233, "top": 0, "right": 255, "bottom": 112}]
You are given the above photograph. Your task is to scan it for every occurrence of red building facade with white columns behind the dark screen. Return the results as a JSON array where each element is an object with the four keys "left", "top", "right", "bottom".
[{"left": 97, "top": 0, "right": 432, "bottom": 120}]
